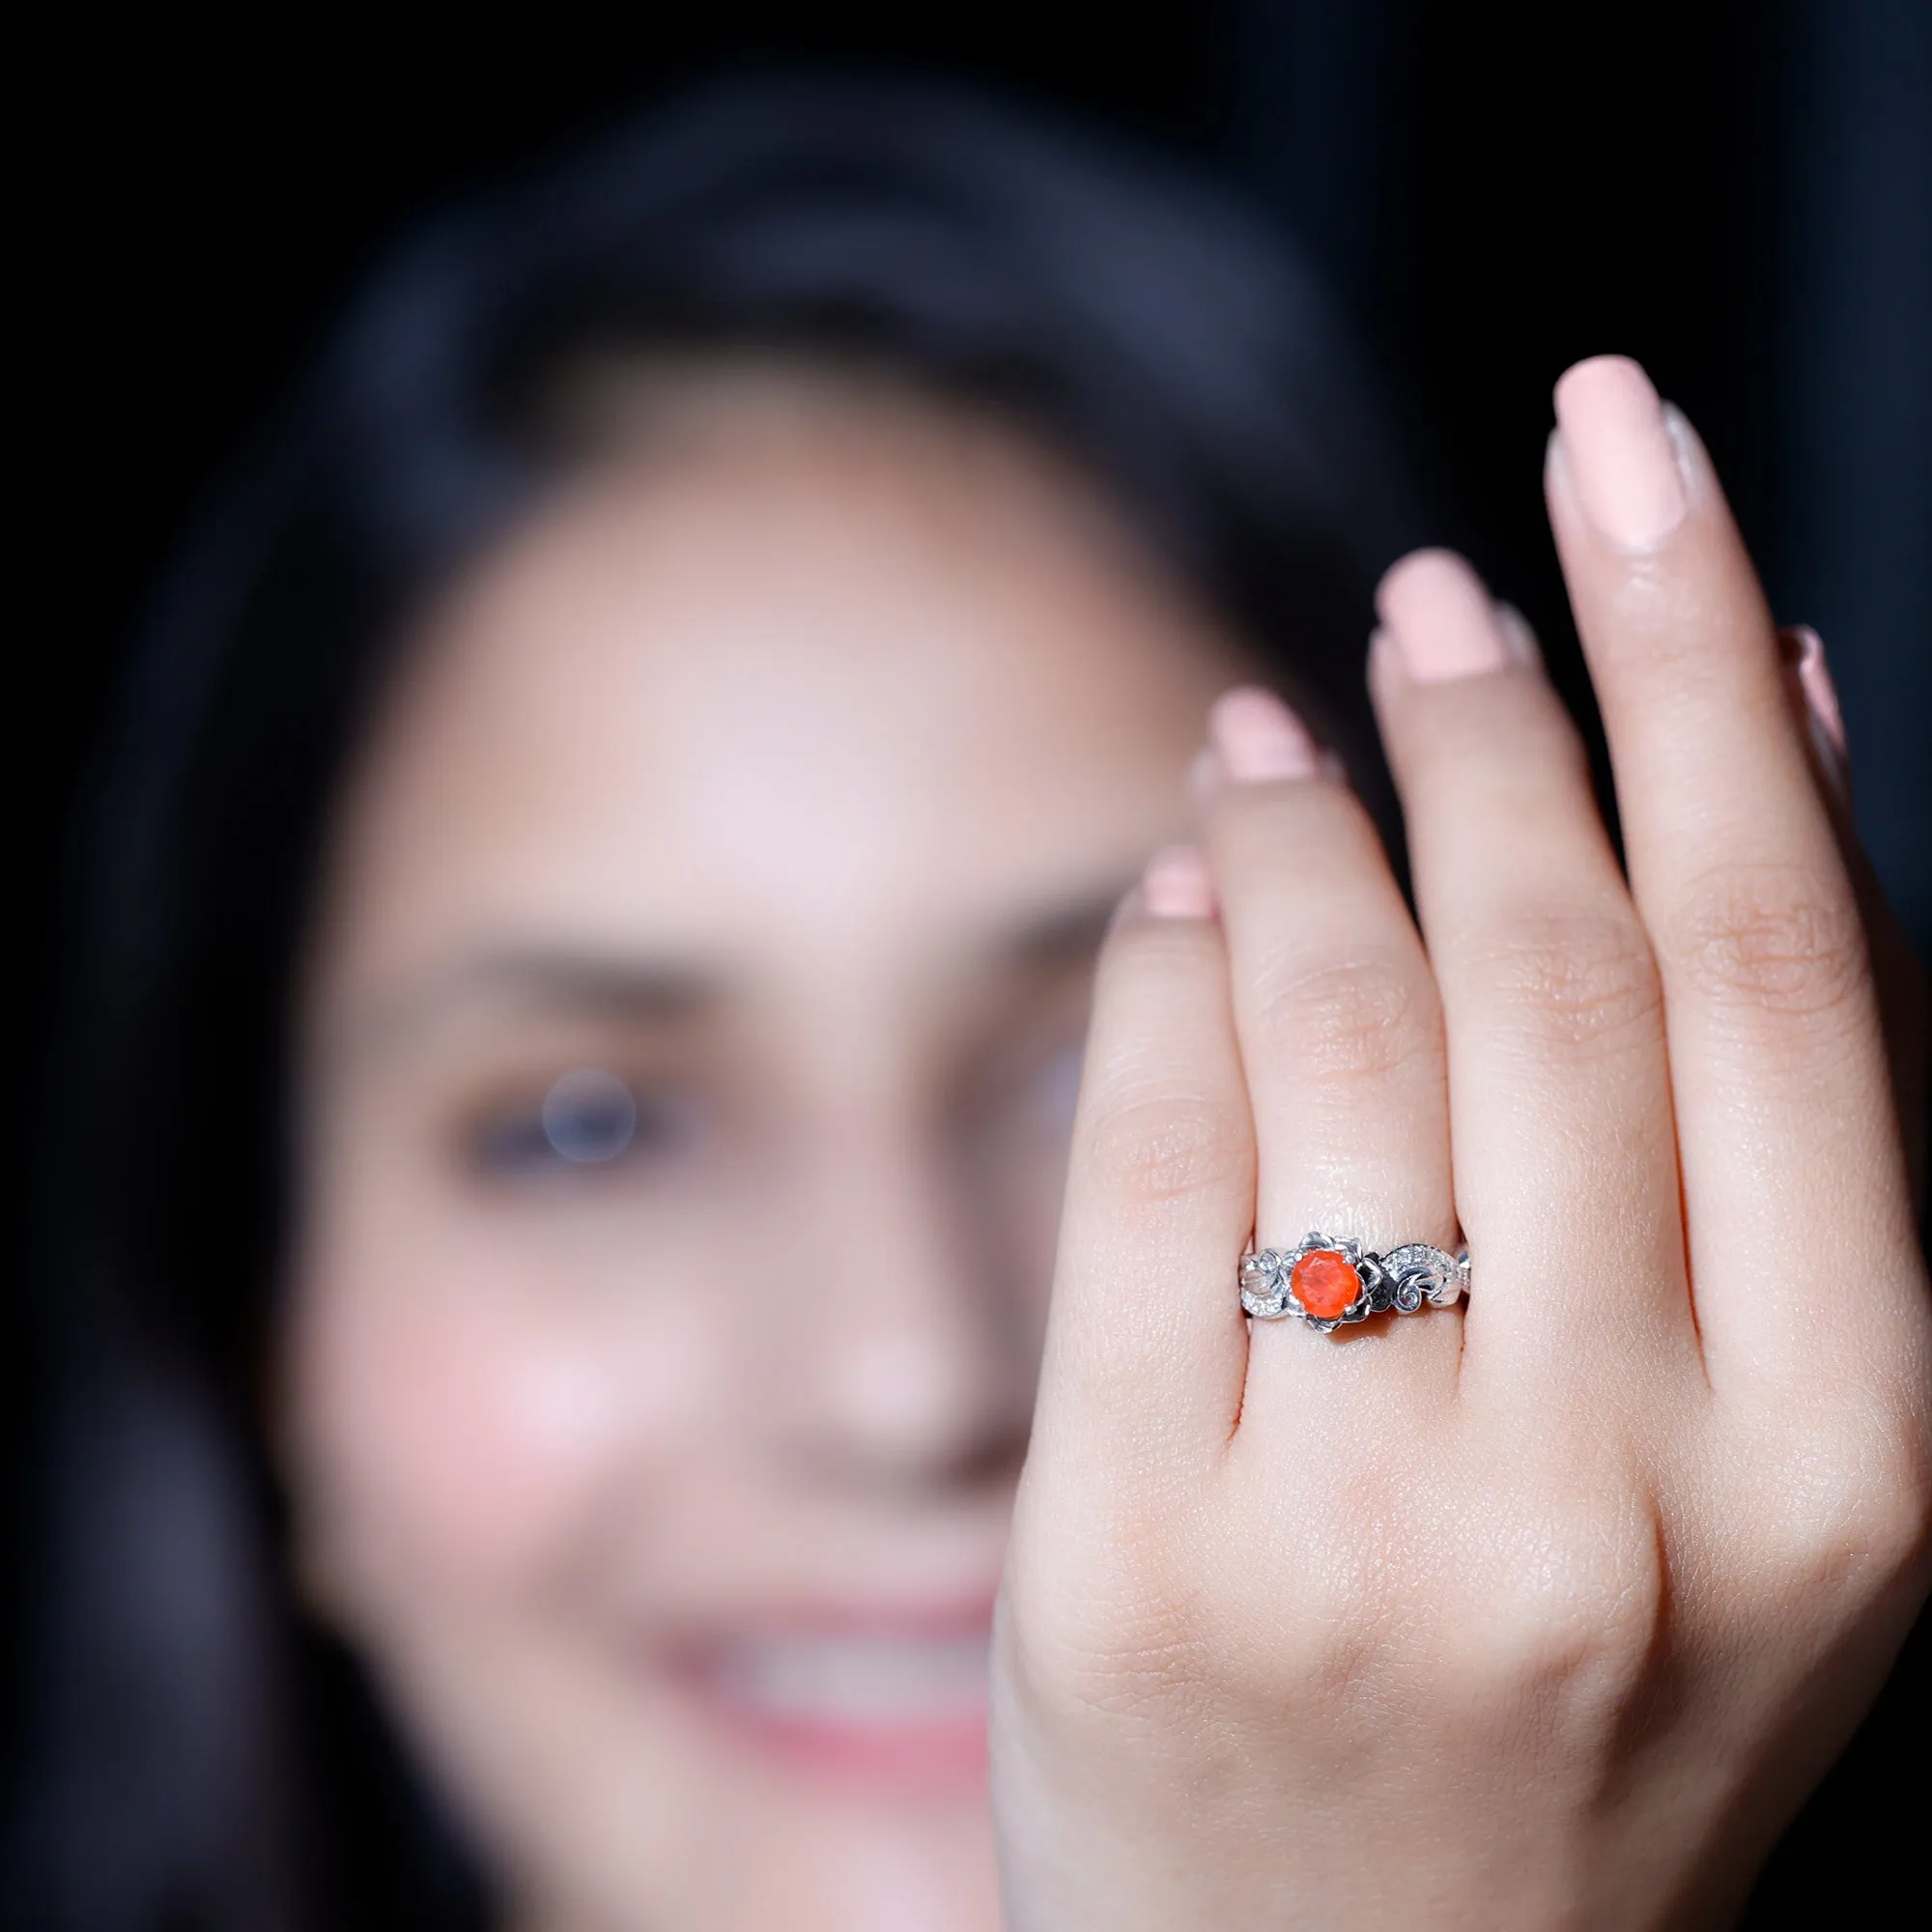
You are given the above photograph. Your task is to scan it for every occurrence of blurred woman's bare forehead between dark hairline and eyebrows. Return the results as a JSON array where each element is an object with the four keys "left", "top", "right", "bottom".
[{"left": 301, "top": 384, "right": 1235, "bottom": 1005}]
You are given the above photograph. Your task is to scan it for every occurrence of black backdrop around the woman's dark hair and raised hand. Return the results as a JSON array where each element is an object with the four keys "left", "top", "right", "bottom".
[{"left": 0, "top": 0, "right": 1932, "bottom": 1922}]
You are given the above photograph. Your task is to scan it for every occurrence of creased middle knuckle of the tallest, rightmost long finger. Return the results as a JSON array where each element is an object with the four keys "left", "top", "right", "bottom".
[{"left": 1669, "top": 866, "right": 1864, "bottom": 1014}]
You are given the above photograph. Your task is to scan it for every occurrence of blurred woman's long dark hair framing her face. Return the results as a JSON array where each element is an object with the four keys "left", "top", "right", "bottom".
[{"left": 8, "top": 77, "right": 1418, "bottom": 1932}]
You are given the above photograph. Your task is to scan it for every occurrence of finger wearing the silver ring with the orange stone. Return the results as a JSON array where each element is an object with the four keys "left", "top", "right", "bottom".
[{"left": 1209, "top": 690, "right": 1461, "bottom": 1428}]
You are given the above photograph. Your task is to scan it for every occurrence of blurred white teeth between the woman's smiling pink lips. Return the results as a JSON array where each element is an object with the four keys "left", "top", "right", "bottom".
[{"left": 715, "top": 1634, "right": 987, "bottom": 1723}]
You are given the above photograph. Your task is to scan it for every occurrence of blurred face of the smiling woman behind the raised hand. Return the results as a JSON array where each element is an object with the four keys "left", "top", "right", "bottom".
[{"left": 284, "top": 379, "right": 1236, "bottom": 1932}]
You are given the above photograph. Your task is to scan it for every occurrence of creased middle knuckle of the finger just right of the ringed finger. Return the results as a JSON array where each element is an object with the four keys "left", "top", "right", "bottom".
[{"left": 1474, "top": 912, "right": 1663, "bottom": 1059}]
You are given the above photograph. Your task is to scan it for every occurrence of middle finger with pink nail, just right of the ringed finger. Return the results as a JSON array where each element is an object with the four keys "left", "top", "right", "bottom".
[{"left": 1372, "top": 551, "right": 1694, "bottom": 1399}]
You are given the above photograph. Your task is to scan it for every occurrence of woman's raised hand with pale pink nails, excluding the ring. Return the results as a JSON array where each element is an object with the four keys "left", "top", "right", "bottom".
[{"left": 993, "top": 359, "right": 1932, "bottom": 1932}]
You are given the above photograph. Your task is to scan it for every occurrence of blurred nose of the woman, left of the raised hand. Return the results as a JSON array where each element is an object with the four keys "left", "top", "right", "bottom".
[{"left": 769, "top": 1119, "right": 1043, "bottom": 1493}]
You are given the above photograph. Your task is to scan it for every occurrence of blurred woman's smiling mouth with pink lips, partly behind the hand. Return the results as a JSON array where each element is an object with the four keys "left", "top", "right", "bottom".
[{"left": 678, "top": 1621, "right": 989, "bottom": 1791}]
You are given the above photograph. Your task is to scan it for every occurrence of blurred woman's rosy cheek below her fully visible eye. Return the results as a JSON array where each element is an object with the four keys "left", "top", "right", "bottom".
[{"left": 288, "top": 1244, "right": 715, "bottom": 1621}]
